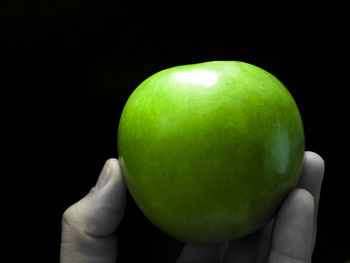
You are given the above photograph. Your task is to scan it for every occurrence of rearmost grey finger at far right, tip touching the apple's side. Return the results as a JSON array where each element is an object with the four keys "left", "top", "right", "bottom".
[{"left": 298, "top": 151, "right": 325, "bottom": 249}]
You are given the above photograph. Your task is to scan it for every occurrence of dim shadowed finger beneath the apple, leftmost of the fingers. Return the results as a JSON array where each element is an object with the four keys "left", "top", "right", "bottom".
[{"left": 177, "top": 242, "right": 228, "bottom": 263}]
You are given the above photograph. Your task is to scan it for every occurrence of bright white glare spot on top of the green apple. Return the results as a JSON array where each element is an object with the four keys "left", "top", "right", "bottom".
[{"left": 173, "top": 70, "right": 219, "bottom": 87}]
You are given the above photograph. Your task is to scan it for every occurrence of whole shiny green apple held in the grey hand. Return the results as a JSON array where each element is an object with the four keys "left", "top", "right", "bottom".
[{"left": 117, "top": 61, "right": 305, "bottom": 243}]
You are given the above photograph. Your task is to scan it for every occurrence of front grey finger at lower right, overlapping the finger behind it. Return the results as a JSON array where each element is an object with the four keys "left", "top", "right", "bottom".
[{"left": 268, "top": 188, "right": 314, "bottom": 263}]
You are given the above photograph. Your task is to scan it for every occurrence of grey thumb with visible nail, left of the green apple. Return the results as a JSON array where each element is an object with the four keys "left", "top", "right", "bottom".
[{"left": 61, "top": 159, "right": 126, "bottom": 263}]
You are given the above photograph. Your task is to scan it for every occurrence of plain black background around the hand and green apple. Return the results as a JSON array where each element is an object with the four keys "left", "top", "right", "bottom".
[{"left": 2, "top": 0, "right": 350, "bottom": 263}]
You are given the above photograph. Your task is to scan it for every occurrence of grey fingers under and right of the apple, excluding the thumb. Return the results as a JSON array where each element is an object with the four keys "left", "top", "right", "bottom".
[{"left": 177, "top": 151, "right": 324, "bottom": 263}]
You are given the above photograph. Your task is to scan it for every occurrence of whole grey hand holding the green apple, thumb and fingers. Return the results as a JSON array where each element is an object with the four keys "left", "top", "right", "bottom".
[{"left": 61, "top": 152, "right": 324, "bottom": 263}]
